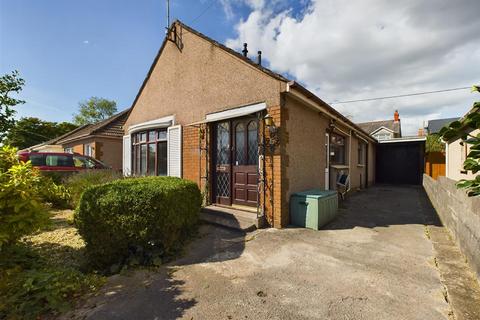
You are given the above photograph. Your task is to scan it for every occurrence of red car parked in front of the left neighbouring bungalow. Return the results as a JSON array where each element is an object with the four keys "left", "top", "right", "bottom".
[{"left": 18, "top": 152, "right": 110, "bottom": 172}]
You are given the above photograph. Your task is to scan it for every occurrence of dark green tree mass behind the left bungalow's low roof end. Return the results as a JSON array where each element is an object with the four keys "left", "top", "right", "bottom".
[{"left": 4, "top": 117, "right": 77, "bottom": 149}]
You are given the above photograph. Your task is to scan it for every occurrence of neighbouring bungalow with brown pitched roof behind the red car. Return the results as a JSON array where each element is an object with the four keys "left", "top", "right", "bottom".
[{"left": 25, "top": 109, "right": 130, "bottom": 170}]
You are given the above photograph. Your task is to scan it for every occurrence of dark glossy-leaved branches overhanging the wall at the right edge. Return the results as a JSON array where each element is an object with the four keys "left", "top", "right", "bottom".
[{"left": 439, "top": 86, "right": 480, "bottom": 197}]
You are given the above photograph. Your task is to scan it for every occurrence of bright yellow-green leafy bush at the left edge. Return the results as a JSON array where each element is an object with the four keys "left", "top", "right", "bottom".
[{"left": 0, "top": 146, "right": 48, "bottom": 249}]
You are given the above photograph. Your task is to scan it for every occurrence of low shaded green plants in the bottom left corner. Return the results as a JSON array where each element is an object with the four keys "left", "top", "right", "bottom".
[{"left": 0, "top": 245, "right": 104, "bottom": 319}]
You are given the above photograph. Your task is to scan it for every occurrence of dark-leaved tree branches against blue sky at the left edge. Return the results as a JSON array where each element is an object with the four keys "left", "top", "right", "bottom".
[{"left": 0, "top": 70, "right": 25, "bottom": 141}]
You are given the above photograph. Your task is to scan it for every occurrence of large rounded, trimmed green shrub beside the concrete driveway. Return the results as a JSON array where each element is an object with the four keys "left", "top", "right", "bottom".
[{"left": 75, "top": 177, "right": 202, "bottom": 272}]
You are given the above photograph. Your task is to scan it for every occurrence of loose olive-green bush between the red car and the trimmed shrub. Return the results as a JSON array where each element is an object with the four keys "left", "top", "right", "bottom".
[{"left": 63, "top": 170, "right": 123, "bottom": 208}]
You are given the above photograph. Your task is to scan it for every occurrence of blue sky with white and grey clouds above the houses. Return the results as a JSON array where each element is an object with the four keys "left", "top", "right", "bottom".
[{"left": 0, "top": 0, "right": 480, "bottom": 135}]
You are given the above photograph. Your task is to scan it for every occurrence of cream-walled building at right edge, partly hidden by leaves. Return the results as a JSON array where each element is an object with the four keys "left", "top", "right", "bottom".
[{"left": 445, "top": 107, "right": 480, "bottom": 181}]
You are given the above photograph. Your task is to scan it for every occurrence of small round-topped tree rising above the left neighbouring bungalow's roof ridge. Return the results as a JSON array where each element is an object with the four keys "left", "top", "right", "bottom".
[{"left": 73, "top": 97, "right": 117, "bottom": 126}]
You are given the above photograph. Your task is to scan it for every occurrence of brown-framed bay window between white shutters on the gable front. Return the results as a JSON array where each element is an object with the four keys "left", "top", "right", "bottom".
[{"left": 132, "top": 128, "right": 167, "bottom": 176}]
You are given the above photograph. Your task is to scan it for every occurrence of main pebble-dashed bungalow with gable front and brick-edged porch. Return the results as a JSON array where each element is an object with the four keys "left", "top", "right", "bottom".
[{"left": 123, "top": 21, "right": 376, "bottom": 227}]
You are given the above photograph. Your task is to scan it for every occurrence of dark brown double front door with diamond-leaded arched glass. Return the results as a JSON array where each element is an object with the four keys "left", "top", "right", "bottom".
[{"left": 213, "top": 118, "right": 258, "bottom": 206}]
